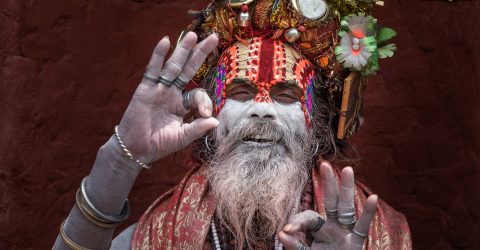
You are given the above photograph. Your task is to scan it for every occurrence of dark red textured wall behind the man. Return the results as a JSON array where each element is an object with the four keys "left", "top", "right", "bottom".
[{"left": 0, "top": 0, "right": 480, "bottom": 249}]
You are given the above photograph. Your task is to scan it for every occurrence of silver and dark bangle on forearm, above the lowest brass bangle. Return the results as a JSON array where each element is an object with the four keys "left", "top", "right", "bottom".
[{"left": 76, "top": 177, "right": 130, "bottom": 228}]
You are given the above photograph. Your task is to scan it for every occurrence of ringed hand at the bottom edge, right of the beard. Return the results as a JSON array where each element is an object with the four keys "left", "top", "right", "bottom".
[{"left": 278, "top": 163, "right": 378, "bottom": 250}]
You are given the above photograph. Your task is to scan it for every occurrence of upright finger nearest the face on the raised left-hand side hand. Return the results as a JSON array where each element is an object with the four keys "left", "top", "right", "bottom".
[{"left": 180, "top": 34, "right": 218, "bottom": 81}]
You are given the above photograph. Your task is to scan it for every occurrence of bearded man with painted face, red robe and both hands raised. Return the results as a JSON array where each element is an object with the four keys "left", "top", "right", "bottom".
[{"left": 54, "top": 1, "right": 411, "bottom": 249}]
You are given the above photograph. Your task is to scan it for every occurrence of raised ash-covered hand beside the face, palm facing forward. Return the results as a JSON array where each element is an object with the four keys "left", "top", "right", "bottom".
[{"left": 118, "top": 32, "right": 218, "bottom": 163}]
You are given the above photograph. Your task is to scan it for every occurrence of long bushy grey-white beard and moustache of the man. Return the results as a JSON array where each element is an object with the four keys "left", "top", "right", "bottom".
[{"left": 207, "top": 121, "right": 313, "bottom": 249}]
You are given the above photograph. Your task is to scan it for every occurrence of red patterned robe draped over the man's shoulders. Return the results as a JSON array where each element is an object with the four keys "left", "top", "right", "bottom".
[{"left": 132, "top": 164, "right": 412, "bottom": 250}]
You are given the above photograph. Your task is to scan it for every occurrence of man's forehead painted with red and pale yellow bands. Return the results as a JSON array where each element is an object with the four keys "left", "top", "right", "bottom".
[{"left": 219, "top": 37, "right": 314, "bottom": 89}]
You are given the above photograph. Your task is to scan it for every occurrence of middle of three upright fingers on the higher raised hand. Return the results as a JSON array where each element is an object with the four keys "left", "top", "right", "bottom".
[{"left": 160, "top": 32, "right": 197, "bottom": 81}]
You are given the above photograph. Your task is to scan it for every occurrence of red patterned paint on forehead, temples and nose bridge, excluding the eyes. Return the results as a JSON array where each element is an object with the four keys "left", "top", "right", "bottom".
[{"left": 215, "top": 37, "right": 315, "bottom": 125}]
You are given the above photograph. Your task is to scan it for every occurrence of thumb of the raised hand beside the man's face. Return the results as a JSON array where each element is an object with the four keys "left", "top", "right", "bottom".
[{"left": 178, "top": 117, "right": 218, "bottom": 147}]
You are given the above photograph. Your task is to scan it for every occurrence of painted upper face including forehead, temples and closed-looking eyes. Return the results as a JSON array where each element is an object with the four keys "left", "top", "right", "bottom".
[{"left": 214, "top": 38, "right": 315, "bottom": 125}]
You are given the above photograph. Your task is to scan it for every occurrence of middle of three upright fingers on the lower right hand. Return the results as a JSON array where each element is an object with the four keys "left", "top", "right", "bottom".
[{"left": 337, "top": 167, "right": 355, "bottom": 214}]
